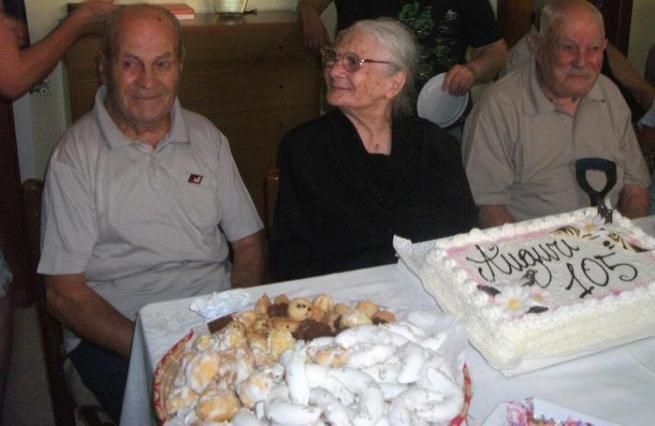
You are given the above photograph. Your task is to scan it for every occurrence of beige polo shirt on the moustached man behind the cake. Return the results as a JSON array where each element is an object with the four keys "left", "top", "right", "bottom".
[{"left": 462, "top": 58, "right": 650, "bottom": 221}]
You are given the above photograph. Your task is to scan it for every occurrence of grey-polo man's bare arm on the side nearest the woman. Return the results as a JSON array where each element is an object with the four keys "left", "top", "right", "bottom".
[{"left": 232, "top": 231, "right": 265, "bottom": 287}]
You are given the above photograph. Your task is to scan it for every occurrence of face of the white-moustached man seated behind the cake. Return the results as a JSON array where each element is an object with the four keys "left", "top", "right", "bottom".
[{"left": 537, "top": 13, "right": 607, "bottom": 98}]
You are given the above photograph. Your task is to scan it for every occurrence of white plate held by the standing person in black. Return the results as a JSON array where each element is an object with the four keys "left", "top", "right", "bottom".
[{"left": 416, "top": 73, "right": 469, "bottom": 127}]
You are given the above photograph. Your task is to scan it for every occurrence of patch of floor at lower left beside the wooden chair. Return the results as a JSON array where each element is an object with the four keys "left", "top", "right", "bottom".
[{"left": 0, "top": 307, "right": 54, "bottom": 426}]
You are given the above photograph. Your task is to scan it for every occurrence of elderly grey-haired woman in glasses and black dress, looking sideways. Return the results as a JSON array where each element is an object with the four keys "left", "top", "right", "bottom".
[{"left": 271, "top": 18, "right": 477, "bottom": 279}]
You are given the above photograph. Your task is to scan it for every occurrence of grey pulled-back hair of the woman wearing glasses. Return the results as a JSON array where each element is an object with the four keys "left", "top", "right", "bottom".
[{"left": 336, "top": 18, "right": 419, "bottom": 116}]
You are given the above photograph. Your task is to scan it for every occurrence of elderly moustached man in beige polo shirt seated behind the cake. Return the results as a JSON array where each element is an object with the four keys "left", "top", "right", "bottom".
[{"left": 462, "top": 0, "right": 650, "bottom": 227}]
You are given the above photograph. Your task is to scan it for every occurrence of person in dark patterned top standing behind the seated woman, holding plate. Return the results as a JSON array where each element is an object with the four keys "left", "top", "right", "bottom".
[{"left": 298, "top": 0, "right": 507, "bottom": 99}]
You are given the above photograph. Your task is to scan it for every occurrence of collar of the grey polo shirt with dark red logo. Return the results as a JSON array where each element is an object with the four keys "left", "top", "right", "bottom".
[{"left": 94, "top": 86, "right": 190, "bottom": 149}]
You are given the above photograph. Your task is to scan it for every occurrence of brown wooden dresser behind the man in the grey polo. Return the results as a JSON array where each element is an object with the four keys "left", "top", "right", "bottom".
[{"left": 65, "top": 11, "right": 321, "bottom": 220}]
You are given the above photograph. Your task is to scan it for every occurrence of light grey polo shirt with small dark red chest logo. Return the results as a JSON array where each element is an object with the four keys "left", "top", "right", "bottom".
[{"left": 38, "top": 87, "right": 263, "bottom": 350}]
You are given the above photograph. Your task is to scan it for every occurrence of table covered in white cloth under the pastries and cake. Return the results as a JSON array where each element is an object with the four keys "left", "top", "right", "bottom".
[{"left": 121, "top": 216, "right": 655, "bottom": 425}]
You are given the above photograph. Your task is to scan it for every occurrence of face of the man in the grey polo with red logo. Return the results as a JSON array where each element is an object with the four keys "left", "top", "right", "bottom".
[{"left": 103, "top": 12, "right": 182, "bottom": 129}]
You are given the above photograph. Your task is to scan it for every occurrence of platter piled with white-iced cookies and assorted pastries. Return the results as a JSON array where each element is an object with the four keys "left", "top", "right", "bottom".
[{"left": 153, "top": 294, "right": 471, "bottom": 426}]
